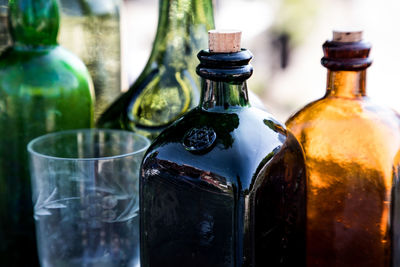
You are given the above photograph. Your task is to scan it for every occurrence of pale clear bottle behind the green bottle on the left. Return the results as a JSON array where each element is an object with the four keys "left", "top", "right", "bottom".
[{"left": 59, "top": 0, "right": 121, "bottom": 118}]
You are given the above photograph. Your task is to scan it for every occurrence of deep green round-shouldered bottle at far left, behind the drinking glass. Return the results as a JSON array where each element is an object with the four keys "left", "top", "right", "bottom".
[{"left": 0, "top": 0, "right": 93, "bottom": 266}]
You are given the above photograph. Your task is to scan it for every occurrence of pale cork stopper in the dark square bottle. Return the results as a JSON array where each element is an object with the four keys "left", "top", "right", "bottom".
[{"left": 208, "top": 30, "right": 242, "bottom": 53}]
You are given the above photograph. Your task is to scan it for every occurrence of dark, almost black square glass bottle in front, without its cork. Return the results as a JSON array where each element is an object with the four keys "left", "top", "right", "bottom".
[{"left": 140, "top": 30, "right": 306, "bottom": 267}]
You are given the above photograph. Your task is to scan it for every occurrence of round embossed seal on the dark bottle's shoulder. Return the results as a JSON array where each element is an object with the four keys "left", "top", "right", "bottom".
[{"left": 183, "top": 126, "right": 217, "bottom": 152}]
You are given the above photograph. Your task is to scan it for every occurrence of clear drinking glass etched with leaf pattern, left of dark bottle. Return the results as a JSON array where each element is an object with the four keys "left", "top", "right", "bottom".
[{"left": 28, "top": 130, "right": 150, "bottom": 267}]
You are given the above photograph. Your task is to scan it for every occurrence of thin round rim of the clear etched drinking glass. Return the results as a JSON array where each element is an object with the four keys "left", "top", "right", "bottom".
[{"left": 27, "top": 128, "right": 151, "bottom": 161}]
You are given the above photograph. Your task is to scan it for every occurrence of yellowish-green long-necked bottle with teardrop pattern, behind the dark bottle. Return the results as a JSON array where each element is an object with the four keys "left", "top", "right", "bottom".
[{"left": 98, "top": 0, "right": 214, "bottom": 139}]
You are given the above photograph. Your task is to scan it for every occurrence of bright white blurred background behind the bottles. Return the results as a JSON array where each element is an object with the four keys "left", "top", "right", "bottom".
[{"left": 121, "top": 0, "right": 400, "bottom": 122}]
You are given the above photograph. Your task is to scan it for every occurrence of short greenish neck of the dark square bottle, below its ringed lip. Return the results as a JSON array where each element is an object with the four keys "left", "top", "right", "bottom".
[{"left": 200, "top": 78, "right": 250, "bottom": 111}]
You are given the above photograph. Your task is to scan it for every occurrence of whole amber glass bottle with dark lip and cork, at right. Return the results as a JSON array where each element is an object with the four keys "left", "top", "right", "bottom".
[{"left": 287, "top": 32, "right": 400, "bottom": 267}]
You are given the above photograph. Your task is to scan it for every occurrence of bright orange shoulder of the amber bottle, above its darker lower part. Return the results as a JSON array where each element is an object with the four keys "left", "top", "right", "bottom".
[{"left": 287, "top": 98, "right": 400, "bottom": 170}]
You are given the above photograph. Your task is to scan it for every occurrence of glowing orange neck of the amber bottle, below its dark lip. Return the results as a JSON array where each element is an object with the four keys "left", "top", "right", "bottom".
[{"left": 326, "top": 69, "right": 367, "bottom": 98}]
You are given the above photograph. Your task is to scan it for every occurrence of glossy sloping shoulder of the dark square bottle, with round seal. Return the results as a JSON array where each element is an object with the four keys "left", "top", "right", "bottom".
[{"left": 144, "top": 108, "right": 302, "bottom": 191}]
